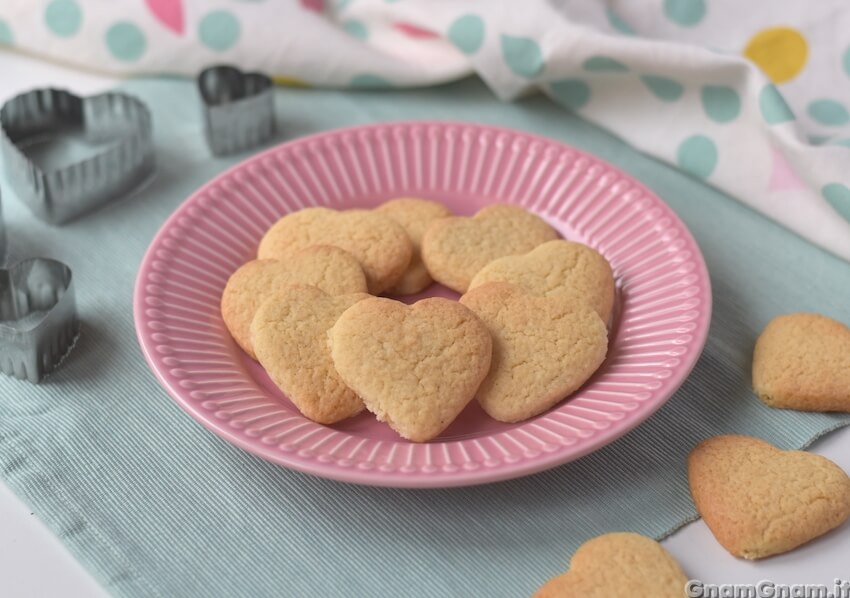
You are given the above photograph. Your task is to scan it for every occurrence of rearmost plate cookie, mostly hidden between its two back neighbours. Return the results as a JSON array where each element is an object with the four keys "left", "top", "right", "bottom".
[{"left": 377, "top": 197, "right": 452, "bottom": 295}]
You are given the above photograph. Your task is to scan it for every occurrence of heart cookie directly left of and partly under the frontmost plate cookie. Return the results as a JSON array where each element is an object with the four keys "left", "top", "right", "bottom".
[{"left": 251, "top": 285, "right": 370, "bottom": 424}]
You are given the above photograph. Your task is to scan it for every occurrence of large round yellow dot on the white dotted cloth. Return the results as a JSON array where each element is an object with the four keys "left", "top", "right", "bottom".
[{"left": 744, "top": 27, "right": 809, "bottom": 83}]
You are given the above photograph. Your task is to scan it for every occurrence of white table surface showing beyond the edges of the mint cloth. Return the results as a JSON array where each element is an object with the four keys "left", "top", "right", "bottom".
[{"left": 0, "top": 50, "right": 850, "bottom": 598}]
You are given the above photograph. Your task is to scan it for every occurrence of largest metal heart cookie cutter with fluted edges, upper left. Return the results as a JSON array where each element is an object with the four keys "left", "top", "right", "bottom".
[{"left": 0, "top": 89, "right": 154, "bottom": 224}]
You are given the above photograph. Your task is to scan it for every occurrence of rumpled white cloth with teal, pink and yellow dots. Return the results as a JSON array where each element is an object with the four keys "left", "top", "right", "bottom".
[{"left": 0, "top": 0, "right": 850, "bottom": 259}]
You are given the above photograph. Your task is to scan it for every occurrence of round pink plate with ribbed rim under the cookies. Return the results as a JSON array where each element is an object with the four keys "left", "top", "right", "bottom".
[{"left": 135, "top": 122, "right": 711, "bottom": 487}]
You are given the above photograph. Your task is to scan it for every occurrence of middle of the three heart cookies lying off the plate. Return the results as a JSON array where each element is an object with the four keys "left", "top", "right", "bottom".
[{"left": 688, "top": 435, "right": 850, "bottom": 559}]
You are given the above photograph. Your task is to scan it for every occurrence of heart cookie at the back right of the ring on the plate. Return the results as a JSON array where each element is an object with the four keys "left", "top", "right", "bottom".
[{"left": 422, "top": 204, "right": 558, "bottom": 293}]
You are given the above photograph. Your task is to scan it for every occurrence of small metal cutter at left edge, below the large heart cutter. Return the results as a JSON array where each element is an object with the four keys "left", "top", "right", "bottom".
[{"left": 0, "top": 258, "right": 80, "bottom": 383}]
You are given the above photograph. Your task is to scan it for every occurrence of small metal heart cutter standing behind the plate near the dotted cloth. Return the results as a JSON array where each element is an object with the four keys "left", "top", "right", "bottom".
[{"left": 198, "top": 66, "right": 275, "bottom": 156}]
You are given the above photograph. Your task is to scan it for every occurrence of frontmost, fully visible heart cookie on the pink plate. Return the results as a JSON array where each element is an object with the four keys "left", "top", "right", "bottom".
[{"left": 330, "top": 297, "right": 491, "bottom": 442}]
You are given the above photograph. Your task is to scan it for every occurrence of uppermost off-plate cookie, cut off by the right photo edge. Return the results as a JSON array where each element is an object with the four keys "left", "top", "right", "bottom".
[{"left": 753, "top": 313, "right": 850, "bottom": 412}]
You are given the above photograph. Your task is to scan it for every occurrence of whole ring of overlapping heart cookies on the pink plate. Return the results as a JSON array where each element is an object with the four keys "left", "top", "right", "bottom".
[{"left": 221, "top": 198, "right": 614, "bottom": 442}]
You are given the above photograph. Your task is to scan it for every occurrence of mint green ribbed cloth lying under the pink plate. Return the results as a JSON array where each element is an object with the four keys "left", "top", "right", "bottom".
[{"left": 0, "top": 80, "right": 850, "bottom": 598}]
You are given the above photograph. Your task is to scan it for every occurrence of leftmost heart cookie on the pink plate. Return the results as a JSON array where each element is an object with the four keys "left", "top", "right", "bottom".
[{"left": 221, "top": 245, "right": 366, "bottom": 358}]
